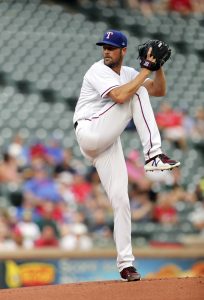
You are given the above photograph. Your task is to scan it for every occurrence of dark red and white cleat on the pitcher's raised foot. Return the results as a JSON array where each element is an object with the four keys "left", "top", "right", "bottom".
[{"left": 144, "top": 153, "right": 181, "bottom": 171}]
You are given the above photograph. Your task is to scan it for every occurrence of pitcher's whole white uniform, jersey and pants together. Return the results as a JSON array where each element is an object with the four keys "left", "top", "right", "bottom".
[{"left": 73, "top": 60, "right": 162, "bottom": 272}]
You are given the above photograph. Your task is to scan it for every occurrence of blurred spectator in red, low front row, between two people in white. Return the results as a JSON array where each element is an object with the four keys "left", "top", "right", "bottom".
[{"left": 35, "top": 225, "right": 59, "bottom": 248}]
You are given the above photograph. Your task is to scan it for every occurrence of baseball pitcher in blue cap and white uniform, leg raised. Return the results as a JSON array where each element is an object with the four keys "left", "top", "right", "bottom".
[{"left": 73, "top": 30, "right": 180, "bottom": 281}]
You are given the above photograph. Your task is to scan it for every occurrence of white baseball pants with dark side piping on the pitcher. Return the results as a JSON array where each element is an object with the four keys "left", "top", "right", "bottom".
[{"left": 76, "top": 87, "right": 162, "bottom": 272}]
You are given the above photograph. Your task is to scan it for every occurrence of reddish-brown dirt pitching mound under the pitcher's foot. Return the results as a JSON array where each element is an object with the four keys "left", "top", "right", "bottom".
[{"left": 0, "top": 277, "right": 204, "bottom": 300}]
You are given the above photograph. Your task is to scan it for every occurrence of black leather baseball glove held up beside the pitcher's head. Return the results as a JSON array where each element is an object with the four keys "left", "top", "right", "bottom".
[{"left": 138, "top": 40, "right": 171, "bottom": 71}]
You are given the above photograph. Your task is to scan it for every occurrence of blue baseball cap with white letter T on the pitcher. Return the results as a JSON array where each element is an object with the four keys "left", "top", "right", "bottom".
[{"left": 96, "top": 30, "right": 127, "bottom": 48}]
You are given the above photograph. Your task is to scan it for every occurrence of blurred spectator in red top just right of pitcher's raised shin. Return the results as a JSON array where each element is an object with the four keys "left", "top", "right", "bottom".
[{"left": 156, "top": 102, "right": 187, "bottom": 150}]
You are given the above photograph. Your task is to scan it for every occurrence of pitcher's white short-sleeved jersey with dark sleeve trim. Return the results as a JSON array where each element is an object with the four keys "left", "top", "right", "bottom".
[{"left": 73, "top": 59, "right": 139, "bottom": 123}]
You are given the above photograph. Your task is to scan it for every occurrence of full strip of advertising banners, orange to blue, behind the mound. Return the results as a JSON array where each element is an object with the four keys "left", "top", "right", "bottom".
[{"left": 0, "top": 258, "right": 204, "bottom": 288}]
